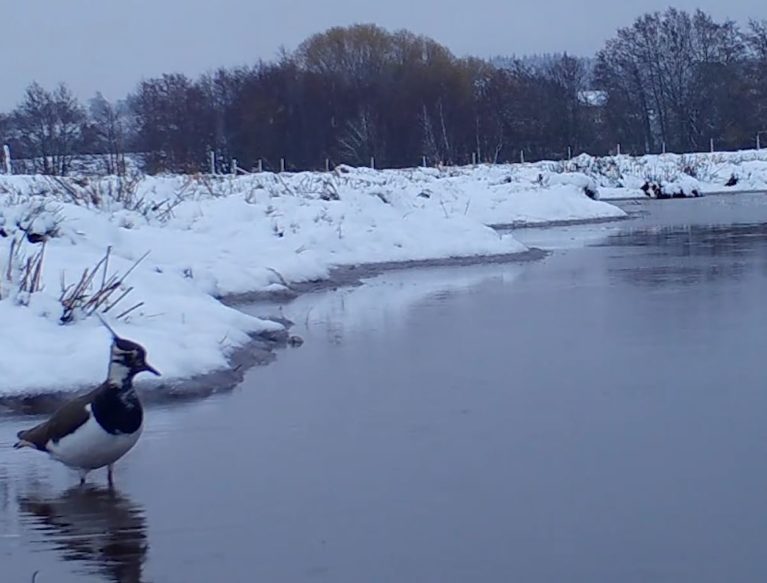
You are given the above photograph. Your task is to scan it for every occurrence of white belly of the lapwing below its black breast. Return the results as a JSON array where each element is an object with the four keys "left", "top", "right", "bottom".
[{"left": 47, "top": 415, "right": 143, "bottom": 470}]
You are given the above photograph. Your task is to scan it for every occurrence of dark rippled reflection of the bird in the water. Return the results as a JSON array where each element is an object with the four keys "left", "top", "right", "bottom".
[{"left": 19, "top": 486, "right": 149, "bottom": 583}]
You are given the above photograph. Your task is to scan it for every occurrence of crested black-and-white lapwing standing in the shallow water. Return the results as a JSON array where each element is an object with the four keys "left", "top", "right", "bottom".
[{"left": 14, "top": 328, "right": 160, "bottom": 486}]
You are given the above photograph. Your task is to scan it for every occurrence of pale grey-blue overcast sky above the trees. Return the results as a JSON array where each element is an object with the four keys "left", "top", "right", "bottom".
[{"left": 0, "top": 0, "right": 767, "bottom": 111}]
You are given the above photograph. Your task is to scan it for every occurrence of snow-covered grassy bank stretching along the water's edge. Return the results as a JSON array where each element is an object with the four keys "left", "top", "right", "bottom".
[{"left": 0, "top": 152, "right": 767, "bottom": 395}]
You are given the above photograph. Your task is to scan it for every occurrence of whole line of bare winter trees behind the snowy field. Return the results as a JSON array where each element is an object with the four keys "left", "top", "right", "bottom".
[{"left": 0, "top": 9, "right": 767, "bottom": 174}]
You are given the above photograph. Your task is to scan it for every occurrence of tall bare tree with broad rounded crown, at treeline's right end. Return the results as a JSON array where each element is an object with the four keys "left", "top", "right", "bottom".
[{"left": 596, "top": 8, "right": 743, "bottom": 151}]
